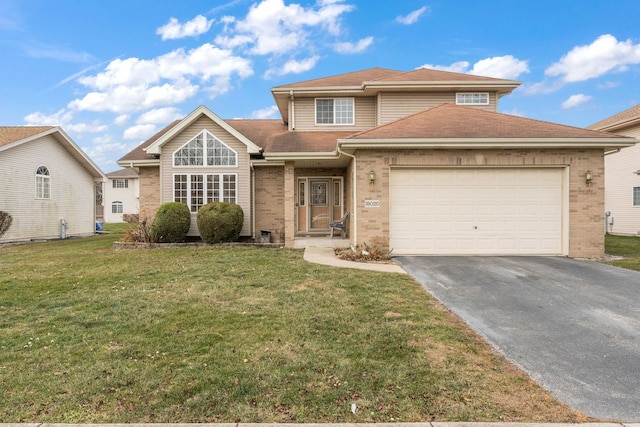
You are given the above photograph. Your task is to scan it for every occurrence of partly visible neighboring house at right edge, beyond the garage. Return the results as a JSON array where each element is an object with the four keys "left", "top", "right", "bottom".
[{"left": 587, "top": 105, "right": 640, "bottom": 235}]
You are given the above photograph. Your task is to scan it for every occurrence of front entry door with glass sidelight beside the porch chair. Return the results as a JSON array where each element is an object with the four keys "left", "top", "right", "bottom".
[{"left": 297, "top": 177, "right": 343, "bottom": 233}]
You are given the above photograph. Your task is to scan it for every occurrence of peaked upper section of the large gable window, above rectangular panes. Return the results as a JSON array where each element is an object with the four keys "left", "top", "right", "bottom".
[{"left": 173, "top": 131, "right": 238, "bottom": 166}]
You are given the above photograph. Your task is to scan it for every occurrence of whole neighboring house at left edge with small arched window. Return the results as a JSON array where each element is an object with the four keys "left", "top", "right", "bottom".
[{"left": 0, "top": 126, "right": 105, "bottom": 242}]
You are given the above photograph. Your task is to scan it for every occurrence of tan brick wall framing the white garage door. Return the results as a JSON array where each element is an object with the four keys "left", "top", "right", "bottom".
[{"left": 355, "top": 149, "right": 604, "bottom": 258}]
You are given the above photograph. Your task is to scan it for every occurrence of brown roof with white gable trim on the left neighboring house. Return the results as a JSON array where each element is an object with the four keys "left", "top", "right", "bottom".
[{"left": 0, "top": 126, "right": 105, "bottom": 179}]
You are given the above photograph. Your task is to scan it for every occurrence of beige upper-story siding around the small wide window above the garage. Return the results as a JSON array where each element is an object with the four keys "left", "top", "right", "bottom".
[{"left": 377, "top": 92, "right": 497, "bottom": 125}]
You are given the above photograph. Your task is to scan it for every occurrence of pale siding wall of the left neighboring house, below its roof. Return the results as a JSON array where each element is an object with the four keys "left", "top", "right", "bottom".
[{"left": 0, "top": 136, "right": 95, "bottom": 242}]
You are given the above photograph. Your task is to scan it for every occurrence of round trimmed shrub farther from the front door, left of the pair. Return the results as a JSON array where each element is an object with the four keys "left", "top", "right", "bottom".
[{"left": 149, "top": 202, "right": 191, "bottom": 243}]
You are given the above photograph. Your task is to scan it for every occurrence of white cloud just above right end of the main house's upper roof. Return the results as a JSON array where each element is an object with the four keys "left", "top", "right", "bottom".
[{"left": 421, "top": 55, "right": 529, "bottom": 79}]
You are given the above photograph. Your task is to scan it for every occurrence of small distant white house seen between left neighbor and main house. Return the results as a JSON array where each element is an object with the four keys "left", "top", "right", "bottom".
[{"left": 103, "top": 168, "right": 140, "bottom": 222}]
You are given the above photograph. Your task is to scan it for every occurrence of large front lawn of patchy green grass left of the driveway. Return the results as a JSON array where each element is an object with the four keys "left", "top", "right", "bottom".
[{"left": 0, "top": 226, "right": 587, "bottom": 423}]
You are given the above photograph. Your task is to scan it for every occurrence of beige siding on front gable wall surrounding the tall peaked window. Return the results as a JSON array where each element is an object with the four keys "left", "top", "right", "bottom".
[{"left": 160, "top": 116, "right": 252, "bottom": 236}]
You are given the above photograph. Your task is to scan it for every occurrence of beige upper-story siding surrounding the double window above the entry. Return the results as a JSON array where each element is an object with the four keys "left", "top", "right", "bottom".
[{"left": 289, "top": 95, "right": 376, "bottom": 132}]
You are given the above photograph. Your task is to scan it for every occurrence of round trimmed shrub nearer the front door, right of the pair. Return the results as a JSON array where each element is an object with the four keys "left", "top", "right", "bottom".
[{"left": 197, "top": 202, "right": 244, "bottom": 243}]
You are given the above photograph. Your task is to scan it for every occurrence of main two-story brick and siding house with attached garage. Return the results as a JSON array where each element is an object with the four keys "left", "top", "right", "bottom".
[{"left": 118, "top": 68, "right": 633, "bottom": 257}]
